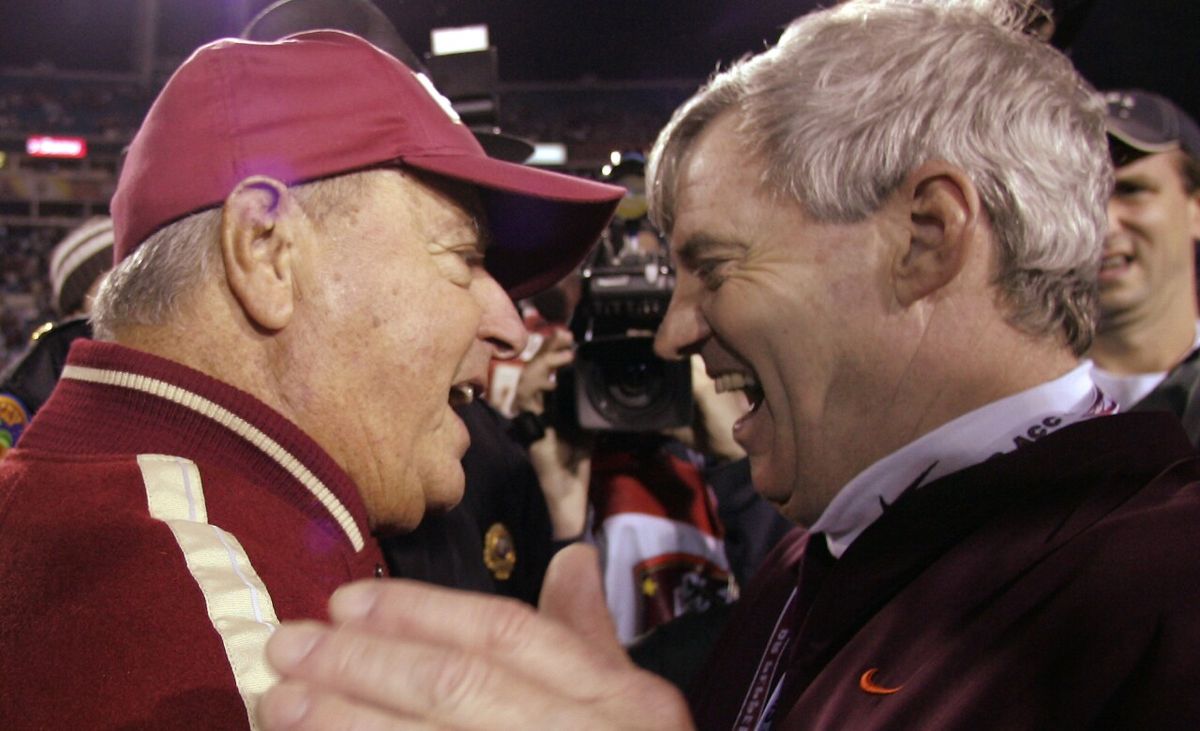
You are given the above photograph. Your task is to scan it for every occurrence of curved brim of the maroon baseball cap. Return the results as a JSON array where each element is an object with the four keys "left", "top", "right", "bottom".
[{"left": 403, "top": 155, "right": 625, "bottom": 299}]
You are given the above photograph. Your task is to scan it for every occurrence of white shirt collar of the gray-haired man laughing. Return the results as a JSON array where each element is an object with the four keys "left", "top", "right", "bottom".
[{"left": 811, "top": 361, "right": 1117, "bottom": 558}]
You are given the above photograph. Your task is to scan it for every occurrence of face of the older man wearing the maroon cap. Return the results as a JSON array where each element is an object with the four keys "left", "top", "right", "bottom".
[{"left": 292, "top": 170, "right": 526, "bottom": 532}]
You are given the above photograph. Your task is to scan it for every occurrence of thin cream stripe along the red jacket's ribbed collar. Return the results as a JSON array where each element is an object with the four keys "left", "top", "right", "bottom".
[{"left": 62, "top": 365, "right": 362, "bottom": 551}]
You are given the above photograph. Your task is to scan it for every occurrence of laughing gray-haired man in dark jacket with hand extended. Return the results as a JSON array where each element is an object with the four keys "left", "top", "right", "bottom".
[{"left": 259, "top": 0, "right": 1200, "bottom": 731}]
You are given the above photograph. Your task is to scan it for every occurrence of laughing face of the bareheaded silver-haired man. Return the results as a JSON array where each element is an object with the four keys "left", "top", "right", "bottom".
[{"left": 656, "top": 114, "right": 902, "bottom": 522}]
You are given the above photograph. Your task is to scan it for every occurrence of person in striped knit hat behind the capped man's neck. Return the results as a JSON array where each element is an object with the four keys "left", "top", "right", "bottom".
[{"left": 0, "top": 216, "right": 113, "bottom": 459}]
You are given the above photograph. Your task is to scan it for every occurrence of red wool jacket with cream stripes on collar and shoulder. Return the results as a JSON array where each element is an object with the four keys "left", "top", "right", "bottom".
[{"left": 0, "top": 341, "right": 382, "bottom": 730}]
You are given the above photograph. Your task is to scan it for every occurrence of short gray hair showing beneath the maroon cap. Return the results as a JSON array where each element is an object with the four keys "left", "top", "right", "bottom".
[{"left": 91, "top": 172, "right": 370, "bottom": 340}]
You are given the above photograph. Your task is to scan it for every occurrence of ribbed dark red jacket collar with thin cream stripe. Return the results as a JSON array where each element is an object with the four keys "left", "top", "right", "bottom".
[{"left": 50, "top": 338, "right": 367, "bottom": 552}]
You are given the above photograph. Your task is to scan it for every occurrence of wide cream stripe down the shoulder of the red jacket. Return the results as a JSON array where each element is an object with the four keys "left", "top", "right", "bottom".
[{"left": 138, "top": 455, "right": 280, "bottom": 729}]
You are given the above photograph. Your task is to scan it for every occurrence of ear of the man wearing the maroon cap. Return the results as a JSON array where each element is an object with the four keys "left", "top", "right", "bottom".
[{"left": 221, "top": 175, "right": 299, "bottom": 331}]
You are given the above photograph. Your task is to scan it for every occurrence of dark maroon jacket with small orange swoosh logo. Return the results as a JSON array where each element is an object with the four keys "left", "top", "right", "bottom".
[{"left": 690, "top": 414, "right": 1200, "bottom": 731}]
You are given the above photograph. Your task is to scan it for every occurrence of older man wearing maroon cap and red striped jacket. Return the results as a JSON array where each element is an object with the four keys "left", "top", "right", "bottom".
[{"left": 0, "top": 31, "right": 622, "bottom": 729}]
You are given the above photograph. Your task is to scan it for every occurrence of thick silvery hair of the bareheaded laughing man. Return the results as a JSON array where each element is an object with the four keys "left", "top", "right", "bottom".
[{"left": 647, "top": 0, "right": 1112, "bottom": 354}]
